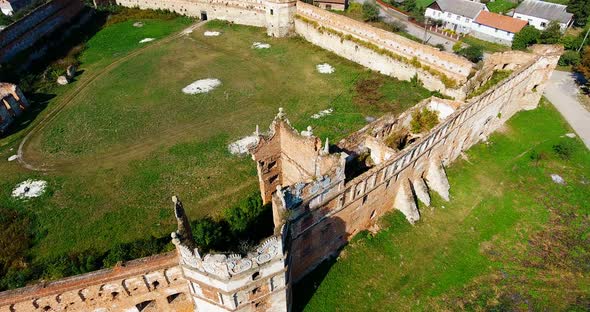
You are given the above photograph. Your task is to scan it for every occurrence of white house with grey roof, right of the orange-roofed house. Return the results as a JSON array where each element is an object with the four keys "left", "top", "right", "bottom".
[{"left": 514, "top": 0, "right": 574, "bottom": 32}]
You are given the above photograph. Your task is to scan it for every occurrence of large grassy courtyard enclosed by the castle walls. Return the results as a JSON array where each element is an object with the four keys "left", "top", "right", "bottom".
[{"left": 0, "top": 18, "right": 431, "bottom": 286}]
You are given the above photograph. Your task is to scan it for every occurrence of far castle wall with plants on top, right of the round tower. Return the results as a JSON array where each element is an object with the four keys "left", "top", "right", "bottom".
[{"left": 295, "top": 2, "right": 473, "bottom": 99}]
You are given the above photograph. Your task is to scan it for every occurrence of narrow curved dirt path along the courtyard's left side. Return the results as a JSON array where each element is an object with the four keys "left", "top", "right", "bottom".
[{"left": 17, "top": 22, "right": 206, "bottom": 171}]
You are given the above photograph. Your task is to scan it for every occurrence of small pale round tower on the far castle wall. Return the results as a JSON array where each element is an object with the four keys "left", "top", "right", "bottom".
[{"left": 264, "top": 0, "right": 297, "bottom": 37}]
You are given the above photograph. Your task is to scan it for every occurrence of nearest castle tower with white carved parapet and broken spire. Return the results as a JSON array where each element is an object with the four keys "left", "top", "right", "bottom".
[{"left": 171, "top": 197, "right": 291, "bottom": 312}]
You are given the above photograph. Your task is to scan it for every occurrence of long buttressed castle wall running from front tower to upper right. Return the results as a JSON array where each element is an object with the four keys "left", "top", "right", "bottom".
[{"left": 284, "top": 47, "right": 561, "bottom": 281}]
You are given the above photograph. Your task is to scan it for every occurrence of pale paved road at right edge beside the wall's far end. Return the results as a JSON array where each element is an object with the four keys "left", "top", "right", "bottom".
[{"left": 545, "top": 70, "right": 590, "bottom": 149}]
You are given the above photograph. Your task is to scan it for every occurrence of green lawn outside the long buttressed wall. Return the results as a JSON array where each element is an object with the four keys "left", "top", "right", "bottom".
[{"left": 295, "top": 101, "right": 590, "bottom": 311}]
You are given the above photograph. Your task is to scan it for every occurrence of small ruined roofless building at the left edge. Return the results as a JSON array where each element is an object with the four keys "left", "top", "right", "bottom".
[{"left": 0, "top": 82, "right": 29, "bottom": 133}]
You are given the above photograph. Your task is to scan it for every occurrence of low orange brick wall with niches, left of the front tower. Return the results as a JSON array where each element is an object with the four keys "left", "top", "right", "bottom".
[{"left": 0, "top": 253, "right": 194, "bottom": 312}]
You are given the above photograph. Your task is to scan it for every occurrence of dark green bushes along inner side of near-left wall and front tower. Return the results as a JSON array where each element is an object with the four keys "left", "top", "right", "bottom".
[{"left": 0, "top": 192, "right": 273, "bottom": 290}]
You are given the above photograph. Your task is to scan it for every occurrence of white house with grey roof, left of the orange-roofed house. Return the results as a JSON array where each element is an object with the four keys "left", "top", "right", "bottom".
[{"left": 424, "top": 0, "right": 488, "bottom": 33}]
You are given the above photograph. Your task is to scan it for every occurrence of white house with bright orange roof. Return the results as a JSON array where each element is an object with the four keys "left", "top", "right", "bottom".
[{"left": 471, "top": 11, "right": 528, "bottom": 44}]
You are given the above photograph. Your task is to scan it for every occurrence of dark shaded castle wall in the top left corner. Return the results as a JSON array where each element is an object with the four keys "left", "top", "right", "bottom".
[{"left": 0, "top": 0, "right": 84, "bottom": 63}]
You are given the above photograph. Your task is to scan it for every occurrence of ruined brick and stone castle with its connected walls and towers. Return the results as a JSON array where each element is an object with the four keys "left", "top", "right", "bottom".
[{"left": 0, "top": 0, "right": 562, "bottom": 312}]
